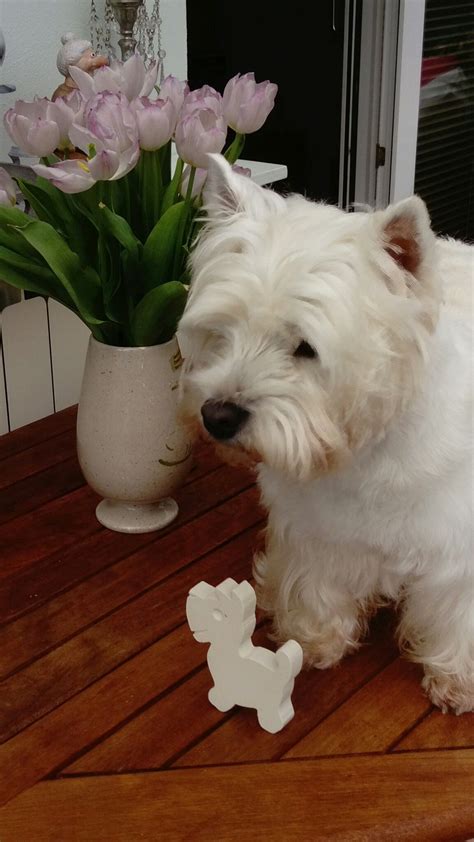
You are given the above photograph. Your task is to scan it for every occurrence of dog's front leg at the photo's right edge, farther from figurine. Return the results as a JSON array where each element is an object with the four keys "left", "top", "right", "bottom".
[{"left": 400, "top": 559, "right": 474, "bottom": 713}]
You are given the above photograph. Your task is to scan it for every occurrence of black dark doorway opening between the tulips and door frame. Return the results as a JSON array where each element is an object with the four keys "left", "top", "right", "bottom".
[{"left": 187, "top": 0, "right": 345, "bottom": 203}]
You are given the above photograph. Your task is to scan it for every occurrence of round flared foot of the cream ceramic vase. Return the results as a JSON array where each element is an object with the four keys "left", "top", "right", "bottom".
[{"left": 95, "top": 497, "right": 178, "bottom": 533}]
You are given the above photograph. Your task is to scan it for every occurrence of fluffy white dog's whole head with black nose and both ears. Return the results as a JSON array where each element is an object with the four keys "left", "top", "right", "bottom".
[{"left": 180, "top": 156, "right": 439, "bottom": 480}]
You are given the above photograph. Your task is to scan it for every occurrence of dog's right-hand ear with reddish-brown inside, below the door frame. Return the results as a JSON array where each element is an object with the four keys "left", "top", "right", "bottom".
[{"left": 374, "top": 196, "right": 435, "bottom": 278}]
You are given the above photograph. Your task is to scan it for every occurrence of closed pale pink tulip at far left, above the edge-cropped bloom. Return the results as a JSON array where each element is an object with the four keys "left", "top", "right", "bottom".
[{"left": 4, "top": 97, "right": 75, "bottom": 158}]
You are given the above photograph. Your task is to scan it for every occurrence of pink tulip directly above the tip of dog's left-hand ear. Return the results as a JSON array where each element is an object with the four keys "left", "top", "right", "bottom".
[{"left": 175, "top": 108, "right": 227, "bottom": 169}]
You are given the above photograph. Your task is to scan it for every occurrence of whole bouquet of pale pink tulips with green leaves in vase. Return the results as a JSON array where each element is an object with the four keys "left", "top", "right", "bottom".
[{"left": 0, "top": 54, "right": 277, "bottom": 346}]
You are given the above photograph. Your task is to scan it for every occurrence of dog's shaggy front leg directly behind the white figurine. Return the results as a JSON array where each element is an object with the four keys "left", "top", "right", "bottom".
[{"left": 254, "top": 531, "right": 379, "bottom": 669}]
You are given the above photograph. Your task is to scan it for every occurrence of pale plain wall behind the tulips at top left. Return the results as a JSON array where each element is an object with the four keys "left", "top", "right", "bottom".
[{"left": 0, "top": 0, "right": 187, "bottom": 161}]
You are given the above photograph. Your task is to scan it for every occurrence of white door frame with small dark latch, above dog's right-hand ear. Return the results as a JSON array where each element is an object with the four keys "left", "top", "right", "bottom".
[{"left": 352, "top": 0, "right": 425, "bottom": 207}]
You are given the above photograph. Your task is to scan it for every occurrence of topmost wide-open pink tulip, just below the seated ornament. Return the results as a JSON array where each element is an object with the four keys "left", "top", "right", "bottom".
[{"left": 69, "top": 53, "right": 159, "bottom": 101}]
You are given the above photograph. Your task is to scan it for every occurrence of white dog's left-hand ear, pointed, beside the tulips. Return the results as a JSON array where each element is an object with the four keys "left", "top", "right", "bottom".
[{"left": 203, "top": 154, "right": 282, "bottom": 222}]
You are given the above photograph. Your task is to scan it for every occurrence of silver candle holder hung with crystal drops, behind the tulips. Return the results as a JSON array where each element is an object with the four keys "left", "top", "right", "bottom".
[{"left": 90, "top": 0, "right": 166, "bottom": 73}]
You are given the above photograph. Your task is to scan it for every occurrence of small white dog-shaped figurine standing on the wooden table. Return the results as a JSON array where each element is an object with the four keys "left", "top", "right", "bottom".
[{"left": 186, "top": 579, "right": 303, "bottom": 734}]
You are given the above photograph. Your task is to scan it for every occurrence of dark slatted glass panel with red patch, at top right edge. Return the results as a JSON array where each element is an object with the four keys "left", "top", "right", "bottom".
[{"left": 415, "top": 0, "right": 474, "bottom": 243}]
